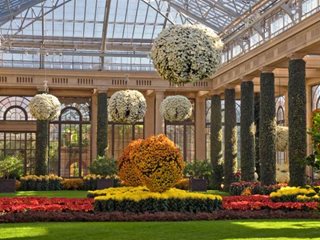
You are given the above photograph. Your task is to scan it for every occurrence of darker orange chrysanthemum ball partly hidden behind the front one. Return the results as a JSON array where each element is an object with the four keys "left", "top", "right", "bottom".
[{"left": 117, "top": 139, "right": 144, "bottom": 187}]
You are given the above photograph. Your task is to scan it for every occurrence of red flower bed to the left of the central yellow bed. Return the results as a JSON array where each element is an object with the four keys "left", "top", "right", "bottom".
[{"left": 0, "top": 197, "right": 93, "bottom": 213}]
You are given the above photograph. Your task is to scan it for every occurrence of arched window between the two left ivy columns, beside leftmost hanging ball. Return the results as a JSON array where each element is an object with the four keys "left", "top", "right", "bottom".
[{"left": 49, "top": 98, "right": 91, "bottom": 177}]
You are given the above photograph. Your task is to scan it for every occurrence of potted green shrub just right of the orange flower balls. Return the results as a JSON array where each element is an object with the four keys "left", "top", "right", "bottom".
[{"left": 184, "top": 160, "right": 212, "bottom": 191}]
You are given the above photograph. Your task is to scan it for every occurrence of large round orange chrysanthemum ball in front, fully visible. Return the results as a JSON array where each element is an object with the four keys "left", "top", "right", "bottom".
[{"left": 130, "top": 134, "right": 184, "bottom": 192}]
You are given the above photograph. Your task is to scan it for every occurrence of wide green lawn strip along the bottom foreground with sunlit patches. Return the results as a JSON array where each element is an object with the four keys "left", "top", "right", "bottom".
[{"left": 0, "top": 220, "right": 320, "bottom": 240}]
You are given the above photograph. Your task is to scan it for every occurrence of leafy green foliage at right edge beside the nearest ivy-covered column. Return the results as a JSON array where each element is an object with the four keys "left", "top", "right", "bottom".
[{"left": 306, "top": 112, "right": 320, "bottom": 170}]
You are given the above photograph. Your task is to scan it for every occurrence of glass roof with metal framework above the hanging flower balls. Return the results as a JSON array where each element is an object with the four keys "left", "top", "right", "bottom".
[{"left": 0, "top": 0, "right": 318, "bottom": 71}]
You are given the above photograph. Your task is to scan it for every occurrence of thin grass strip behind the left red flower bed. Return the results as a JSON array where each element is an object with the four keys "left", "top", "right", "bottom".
[{"left": 0, "top": 190, "right": 87, "bottom": 198}]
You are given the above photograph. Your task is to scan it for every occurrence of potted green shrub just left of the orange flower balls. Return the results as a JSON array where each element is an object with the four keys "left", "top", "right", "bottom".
[{"left": 89, "top": 156, "right": 117, "bottom": 189}]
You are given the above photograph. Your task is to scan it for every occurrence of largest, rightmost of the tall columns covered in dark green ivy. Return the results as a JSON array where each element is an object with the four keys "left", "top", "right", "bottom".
[{"left": 288, "top": 59, "right": 307, "bottom": 186}]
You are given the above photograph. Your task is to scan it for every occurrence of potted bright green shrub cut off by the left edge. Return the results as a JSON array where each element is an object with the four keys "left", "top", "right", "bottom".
[{"left": 0, "top": 156, "right": 23, "bottom": 192}]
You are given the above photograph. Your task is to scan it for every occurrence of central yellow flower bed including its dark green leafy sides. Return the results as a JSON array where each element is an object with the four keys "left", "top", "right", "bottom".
[{"left": 90, "top": 187, "right": 222, "bottom": 213}]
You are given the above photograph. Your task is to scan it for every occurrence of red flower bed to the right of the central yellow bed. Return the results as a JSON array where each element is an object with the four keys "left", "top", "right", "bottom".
[{"left": 222, "top": 195, "right": 318, "bottom": 211}]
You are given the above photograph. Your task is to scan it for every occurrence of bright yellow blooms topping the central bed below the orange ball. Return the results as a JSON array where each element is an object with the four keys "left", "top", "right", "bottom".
[{"left": 89, "top": 187, "right": 222, "bottom": 202}]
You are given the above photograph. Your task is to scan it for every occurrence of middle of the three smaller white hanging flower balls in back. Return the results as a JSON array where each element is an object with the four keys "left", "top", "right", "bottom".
[{"left": 108, "top": 90, "right": 147, "bottom": 123}]
